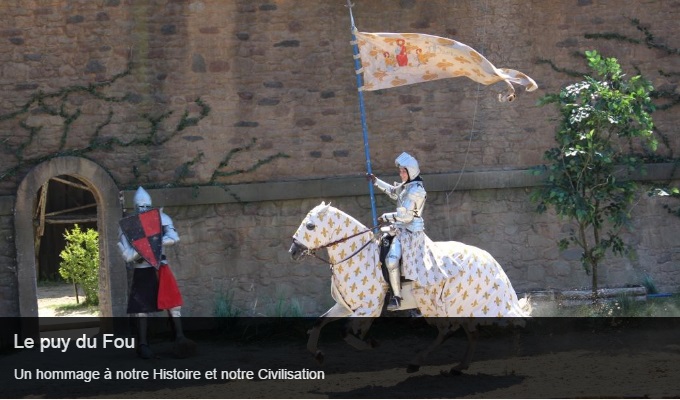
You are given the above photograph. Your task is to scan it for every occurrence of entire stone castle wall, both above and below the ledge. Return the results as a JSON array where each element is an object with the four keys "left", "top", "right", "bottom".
[{"left": 0, "top": 0, "right": 680, "bottom": 315}]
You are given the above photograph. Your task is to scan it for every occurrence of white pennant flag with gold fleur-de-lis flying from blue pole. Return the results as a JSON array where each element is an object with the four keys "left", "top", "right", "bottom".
[{"left": 354, "top": 31, "right": 538, "bottom": 92}]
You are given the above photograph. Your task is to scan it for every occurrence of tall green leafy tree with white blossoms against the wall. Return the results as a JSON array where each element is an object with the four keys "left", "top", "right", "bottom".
[{"left": 531, "top": 51, "right": 657, "bottom": 300}]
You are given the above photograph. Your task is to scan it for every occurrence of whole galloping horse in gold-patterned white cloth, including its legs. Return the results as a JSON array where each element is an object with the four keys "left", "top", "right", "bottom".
[{"left": 289, "top": 202, "right": 531, "bottom": 374}]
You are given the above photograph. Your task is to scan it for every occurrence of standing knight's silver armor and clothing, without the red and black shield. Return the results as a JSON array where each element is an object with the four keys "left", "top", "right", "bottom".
[{"left": 118, "top": 186, "right": 196, "bottom": 359}]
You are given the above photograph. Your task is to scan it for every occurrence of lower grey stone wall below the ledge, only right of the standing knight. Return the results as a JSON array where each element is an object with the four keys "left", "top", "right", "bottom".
[{"left": 154, "top": 184, "right": 680, "bottom": 315}]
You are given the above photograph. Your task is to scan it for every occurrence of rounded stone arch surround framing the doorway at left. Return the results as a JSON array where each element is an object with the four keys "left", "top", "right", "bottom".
[{"left": 14, "top": 157, "right": 127, "bottom": 317}]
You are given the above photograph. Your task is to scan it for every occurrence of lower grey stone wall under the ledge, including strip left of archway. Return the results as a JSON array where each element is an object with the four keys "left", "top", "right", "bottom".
[{"left": 0, "top": 164, "right": 680, "bottom": 316}]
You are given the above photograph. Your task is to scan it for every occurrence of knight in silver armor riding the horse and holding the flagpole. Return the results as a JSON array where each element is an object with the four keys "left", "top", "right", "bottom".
[{"left": 368, "top": 152, "right": 427, "bottom": 311}]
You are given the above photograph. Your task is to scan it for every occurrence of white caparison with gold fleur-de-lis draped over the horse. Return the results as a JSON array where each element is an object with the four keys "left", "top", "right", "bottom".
[{"left": 294, "top": 203, "right": 527, "bottom": 318}]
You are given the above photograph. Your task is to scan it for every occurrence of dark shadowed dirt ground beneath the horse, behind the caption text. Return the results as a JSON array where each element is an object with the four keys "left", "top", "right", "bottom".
[{"left": 0, "top": 318, "right": 680, "bottom": 398}]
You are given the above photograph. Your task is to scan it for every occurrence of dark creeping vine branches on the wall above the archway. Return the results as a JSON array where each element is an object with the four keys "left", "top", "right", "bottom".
[{"left": 0, "top": 58, "right": 288, "bottom": 193}]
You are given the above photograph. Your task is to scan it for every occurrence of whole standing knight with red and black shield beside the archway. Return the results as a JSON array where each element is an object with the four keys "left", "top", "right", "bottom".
[{"left": 118, "top": 186, "right": 196, "bottom": 359}]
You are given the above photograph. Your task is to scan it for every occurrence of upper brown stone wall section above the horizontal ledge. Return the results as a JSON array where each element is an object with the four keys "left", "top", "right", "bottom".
[{"left": 0, "top": 0, "right": 680, "bottom": 191}]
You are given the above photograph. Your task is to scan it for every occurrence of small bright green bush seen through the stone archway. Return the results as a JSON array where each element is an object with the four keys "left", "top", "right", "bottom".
[{"left": 59, "top": 224, "right": 99, "bottom": 305}]
